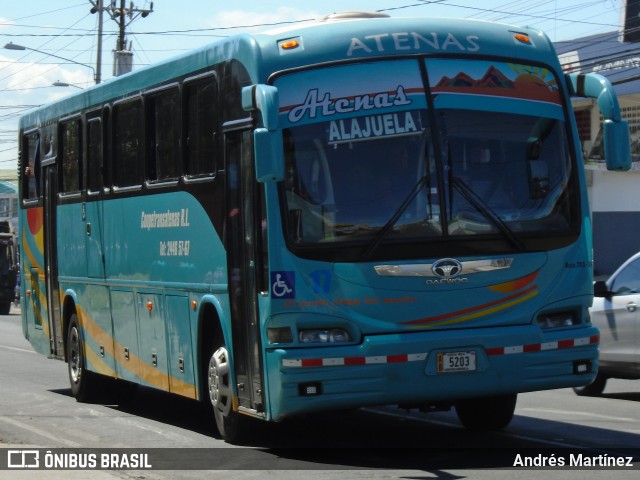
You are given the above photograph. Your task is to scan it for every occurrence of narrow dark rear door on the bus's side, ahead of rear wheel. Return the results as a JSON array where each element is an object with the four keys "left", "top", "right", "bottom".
[{"left": 42, "top": 162, "right": 64, "bottom": 357}]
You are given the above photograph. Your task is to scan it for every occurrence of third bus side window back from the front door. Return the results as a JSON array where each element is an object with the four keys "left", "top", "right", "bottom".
[{"left": 112, "top": 98, "right": 144, "bottom": 187}]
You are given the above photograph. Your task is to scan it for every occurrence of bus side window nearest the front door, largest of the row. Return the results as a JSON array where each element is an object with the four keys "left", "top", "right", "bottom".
[{"left": 184, "top": 77, "right": 218, "bottom": 176}]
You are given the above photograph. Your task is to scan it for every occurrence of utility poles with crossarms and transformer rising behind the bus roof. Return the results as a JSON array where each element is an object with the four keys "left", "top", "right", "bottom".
[{"left": 89, "top": 0, "right": 153, "bottom": 79}]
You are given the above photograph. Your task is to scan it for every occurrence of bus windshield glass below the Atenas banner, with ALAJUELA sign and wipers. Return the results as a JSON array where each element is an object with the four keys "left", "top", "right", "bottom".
[{"left": 282, "top": 61, "right": 579, "bottom": 257}]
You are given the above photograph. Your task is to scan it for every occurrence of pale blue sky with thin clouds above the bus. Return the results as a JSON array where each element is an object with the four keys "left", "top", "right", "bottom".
[{"left": 0, "top": 0, "right": 624, "bottom": 176}]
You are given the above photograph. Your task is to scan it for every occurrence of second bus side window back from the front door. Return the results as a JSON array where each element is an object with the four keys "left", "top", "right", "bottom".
[{"left": 145, "top": 87, "right": 180, "bottom": 181}]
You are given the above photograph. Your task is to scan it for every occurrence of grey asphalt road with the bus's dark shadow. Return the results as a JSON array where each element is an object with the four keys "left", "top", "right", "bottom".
[{"left": 0, "top": 312, "right": 640, "bottom": 480}]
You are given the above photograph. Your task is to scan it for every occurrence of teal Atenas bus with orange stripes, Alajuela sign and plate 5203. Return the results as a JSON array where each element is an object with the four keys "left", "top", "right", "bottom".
[{"left": 19, "top": 13, "right": 630, "bottom": 442}]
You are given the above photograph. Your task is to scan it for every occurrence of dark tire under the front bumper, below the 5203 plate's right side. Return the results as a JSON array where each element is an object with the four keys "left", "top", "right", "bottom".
[{"left": 455, "top": 393, "right": 518, "bottom": 431}]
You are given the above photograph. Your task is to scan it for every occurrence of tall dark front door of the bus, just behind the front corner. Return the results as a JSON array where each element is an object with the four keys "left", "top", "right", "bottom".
[{"left": 224, "top": 125, "right": 264, "bottom": 413}]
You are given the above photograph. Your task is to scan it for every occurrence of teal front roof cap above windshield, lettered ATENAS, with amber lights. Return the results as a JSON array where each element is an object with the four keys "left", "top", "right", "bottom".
[{"left": 255, "top": 17, "right": 555, "bottom": 70}]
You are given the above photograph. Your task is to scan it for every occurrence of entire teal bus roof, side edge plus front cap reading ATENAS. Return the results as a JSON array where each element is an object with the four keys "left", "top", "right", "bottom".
[{"left": 20, "top": 15, "right": 560, "bottom": 129}]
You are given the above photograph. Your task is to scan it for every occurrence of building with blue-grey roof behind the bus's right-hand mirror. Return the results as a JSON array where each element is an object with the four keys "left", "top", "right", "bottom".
[{"left": 556, "top": 0, "right": 640, "bottom": 275}]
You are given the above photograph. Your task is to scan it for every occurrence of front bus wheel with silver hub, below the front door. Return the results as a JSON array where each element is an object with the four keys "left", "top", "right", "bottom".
[{"left": 207, "top": 345, "right": 246, "bottom": 443}]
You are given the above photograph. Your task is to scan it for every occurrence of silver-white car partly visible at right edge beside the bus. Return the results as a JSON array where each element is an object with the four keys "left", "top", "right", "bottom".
[{"left": 574, "top": 252, "right": 640, "bottom": 395}]
